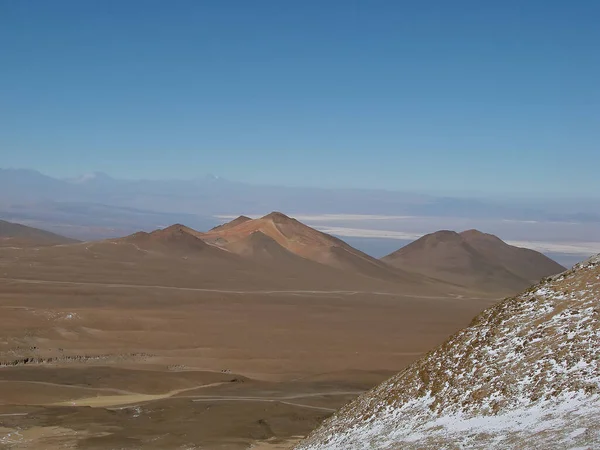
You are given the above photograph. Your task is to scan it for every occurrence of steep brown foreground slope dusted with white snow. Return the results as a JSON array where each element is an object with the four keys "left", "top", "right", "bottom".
[{"left": 297, "top": 256, "right": 600, "bottom": 450}]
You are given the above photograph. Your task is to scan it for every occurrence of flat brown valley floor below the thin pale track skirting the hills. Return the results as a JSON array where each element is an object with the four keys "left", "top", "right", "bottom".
[{"left": 0, "top": 279, "right": 490, "bottom": 449}]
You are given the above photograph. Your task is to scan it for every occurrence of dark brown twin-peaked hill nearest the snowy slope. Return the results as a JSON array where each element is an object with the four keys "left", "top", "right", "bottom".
[{"left": 383, "top": 230, "right": 566, "bottom": 292}]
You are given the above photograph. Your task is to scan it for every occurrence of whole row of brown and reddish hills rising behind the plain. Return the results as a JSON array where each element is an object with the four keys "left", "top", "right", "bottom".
[{"left": 0, "top": 212, "right": 565, "bottom": 295}]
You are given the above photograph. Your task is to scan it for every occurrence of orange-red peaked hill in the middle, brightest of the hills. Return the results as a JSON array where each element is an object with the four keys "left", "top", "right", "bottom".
[{"left": 200, "top": 212, "right": 422, "bottom": 282}]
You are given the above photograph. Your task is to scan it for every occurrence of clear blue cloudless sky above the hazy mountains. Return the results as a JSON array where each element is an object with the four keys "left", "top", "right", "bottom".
[{"left": 0, "top": 0, "right": 600, "bottom": 195}]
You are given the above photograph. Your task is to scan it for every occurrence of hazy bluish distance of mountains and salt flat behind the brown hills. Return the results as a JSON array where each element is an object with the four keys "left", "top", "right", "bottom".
[{"left": 0, "top": 164, "right": 600, "bottom": 266}]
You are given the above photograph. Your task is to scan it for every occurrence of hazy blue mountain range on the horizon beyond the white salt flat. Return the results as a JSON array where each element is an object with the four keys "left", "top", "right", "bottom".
[{"left": 0, "top": 169, "right": 600, "bottom": 222}]
